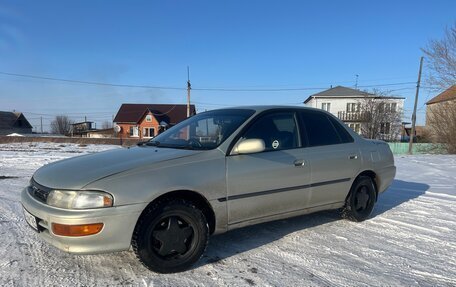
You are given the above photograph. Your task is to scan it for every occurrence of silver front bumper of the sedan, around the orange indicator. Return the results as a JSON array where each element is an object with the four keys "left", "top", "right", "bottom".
[{"left": 21, "top": 188, "right": 147, "bottom": 254}]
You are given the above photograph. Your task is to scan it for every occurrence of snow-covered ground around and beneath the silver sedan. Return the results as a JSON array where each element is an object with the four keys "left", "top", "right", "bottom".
[{"left": 0, "top": 143, "right": 456, "bottom": 286}]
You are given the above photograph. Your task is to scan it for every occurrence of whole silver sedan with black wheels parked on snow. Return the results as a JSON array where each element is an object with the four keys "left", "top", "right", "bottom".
[{"left": 22, "top": 107, "right": 396, "bottom": 273}]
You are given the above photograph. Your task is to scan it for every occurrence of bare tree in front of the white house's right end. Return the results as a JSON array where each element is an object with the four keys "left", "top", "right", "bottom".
[{"left": 357, "top": 90, "right": 402, "bottom": 141}]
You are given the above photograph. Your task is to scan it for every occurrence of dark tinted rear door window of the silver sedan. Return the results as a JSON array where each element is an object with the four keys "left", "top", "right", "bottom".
[{"left": 300, "top": 111, "right": 342, "bottom": 147}]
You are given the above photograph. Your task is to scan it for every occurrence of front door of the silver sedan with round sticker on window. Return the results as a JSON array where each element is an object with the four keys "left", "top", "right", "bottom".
[{"left": 226, "top": 111, "right": 310, "bottom": 224}]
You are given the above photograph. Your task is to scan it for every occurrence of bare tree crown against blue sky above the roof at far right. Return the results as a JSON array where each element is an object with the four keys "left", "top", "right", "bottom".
[{"left": 422, "top": 23, "right": 456, "bottom": 89}]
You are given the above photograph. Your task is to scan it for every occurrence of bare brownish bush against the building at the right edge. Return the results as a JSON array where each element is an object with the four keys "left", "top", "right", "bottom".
[{"left": 426, "top": 101, "right": 456, "bottom": 154}]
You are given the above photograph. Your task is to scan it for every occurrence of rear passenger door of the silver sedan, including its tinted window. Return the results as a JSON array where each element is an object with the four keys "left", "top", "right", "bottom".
[{"left": 299, "top": 110, "right": 361, "bottom": 207}]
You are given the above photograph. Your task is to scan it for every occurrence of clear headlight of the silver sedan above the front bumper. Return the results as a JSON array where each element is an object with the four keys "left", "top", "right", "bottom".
[{"left": 46, "top": 190, "right": 113, "bottom": 209}]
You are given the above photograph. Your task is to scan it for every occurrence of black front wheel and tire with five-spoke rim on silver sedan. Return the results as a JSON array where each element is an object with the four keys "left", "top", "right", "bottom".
[{"left": 132, "top": 199, "right": 209, "bottom": 273}]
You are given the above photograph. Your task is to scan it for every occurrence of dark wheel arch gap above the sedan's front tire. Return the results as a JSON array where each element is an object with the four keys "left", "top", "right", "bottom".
[{"left": 138, "top": 190, "right": 216, "bottom": 234}]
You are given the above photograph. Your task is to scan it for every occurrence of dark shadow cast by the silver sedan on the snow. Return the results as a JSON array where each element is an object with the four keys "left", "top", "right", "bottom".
[{"left": 199, "top": 180, "right": 429, "bottom": 267}]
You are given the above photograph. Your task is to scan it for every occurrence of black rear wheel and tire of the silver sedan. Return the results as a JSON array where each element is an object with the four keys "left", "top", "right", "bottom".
[{"left": 342, "top": 176, "right": 376, "bottom": 222}]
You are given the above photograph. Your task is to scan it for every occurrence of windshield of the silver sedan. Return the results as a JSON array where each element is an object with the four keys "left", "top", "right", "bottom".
[{"left": 145, "top": 109, "right": 255, "bottom": 150}]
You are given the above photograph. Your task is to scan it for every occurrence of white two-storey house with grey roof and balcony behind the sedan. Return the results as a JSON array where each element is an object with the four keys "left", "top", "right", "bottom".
[{"left": 304, "top": 86, "right": 405, "bottom": 139}]
